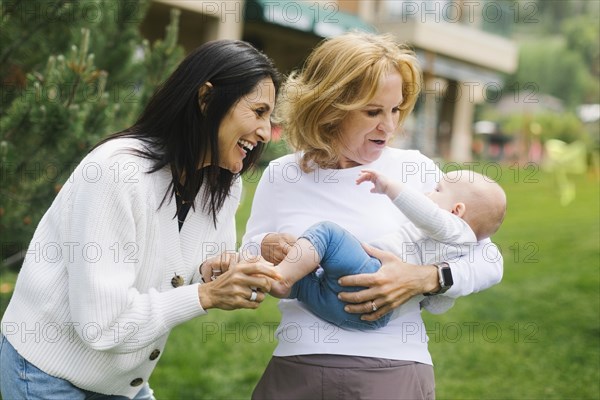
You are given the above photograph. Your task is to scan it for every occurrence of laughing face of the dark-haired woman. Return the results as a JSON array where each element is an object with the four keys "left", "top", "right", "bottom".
[{"left": 219, "top": 78, "right": 275, "bottom": 174}]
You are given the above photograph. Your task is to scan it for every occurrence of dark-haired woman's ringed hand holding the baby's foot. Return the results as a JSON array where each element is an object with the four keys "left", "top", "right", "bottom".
[{"left": 198, "top": 259, "right": 281, "bottom": 310}]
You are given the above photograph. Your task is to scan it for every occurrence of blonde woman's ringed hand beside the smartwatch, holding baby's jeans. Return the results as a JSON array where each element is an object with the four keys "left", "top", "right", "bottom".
[{"left": 339, "top": 244, "right": 439, "bottom": 321}]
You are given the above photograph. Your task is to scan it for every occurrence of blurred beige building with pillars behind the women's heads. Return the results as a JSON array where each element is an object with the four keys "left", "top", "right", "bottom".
[{"left": 142, "top": 0, "right": 519, "bottom": 161}]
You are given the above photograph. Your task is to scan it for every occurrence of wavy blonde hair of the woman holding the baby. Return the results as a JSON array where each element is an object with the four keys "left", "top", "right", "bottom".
[{"left": 274, "top": 32, "right": 421, "bottom": 172}]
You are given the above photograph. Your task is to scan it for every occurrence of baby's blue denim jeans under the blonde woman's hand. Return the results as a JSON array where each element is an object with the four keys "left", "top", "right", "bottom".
[{"left": 289, "top": 222, "right": 391, "bottom": 330}]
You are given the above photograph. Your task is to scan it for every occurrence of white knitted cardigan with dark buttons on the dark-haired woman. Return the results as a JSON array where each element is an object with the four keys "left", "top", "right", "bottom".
[{"left": 2, "top": 139, "right": 241, "bottom": 397}]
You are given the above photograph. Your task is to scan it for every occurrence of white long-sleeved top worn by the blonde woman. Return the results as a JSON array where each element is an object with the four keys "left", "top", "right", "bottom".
[{"left": 243, "top": 148, "right": 502, "bottom": 364}]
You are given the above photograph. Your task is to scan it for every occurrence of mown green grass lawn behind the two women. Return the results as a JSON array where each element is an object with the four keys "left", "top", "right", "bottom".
[{"left": 0, "top": 164, "right": 600, "bottom": 399}]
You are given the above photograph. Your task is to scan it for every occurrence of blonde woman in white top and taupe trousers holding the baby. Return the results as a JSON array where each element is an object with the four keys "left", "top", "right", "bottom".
[{"left": 244, "top": 33, "right": 502, "bottom": 399}]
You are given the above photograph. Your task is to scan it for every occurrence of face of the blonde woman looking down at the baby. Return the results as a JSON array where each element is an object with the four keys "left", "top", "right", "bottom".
[{"left": 338, "top": 70, "right": 403, "bottom": 168}]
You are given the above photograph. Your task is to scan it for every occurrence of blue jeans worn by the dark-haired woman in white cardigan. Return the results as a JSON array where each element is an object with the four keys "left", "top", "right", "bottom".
[{"left": 0, "top": 334, "right": 154, "bottom": 400}]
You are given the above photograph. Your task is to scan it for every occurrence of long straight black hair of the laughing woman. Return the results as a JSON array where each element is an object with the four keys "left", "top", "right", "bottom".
[{"left": 97, "top": 40, "right": 280, "bottom": 225}]
